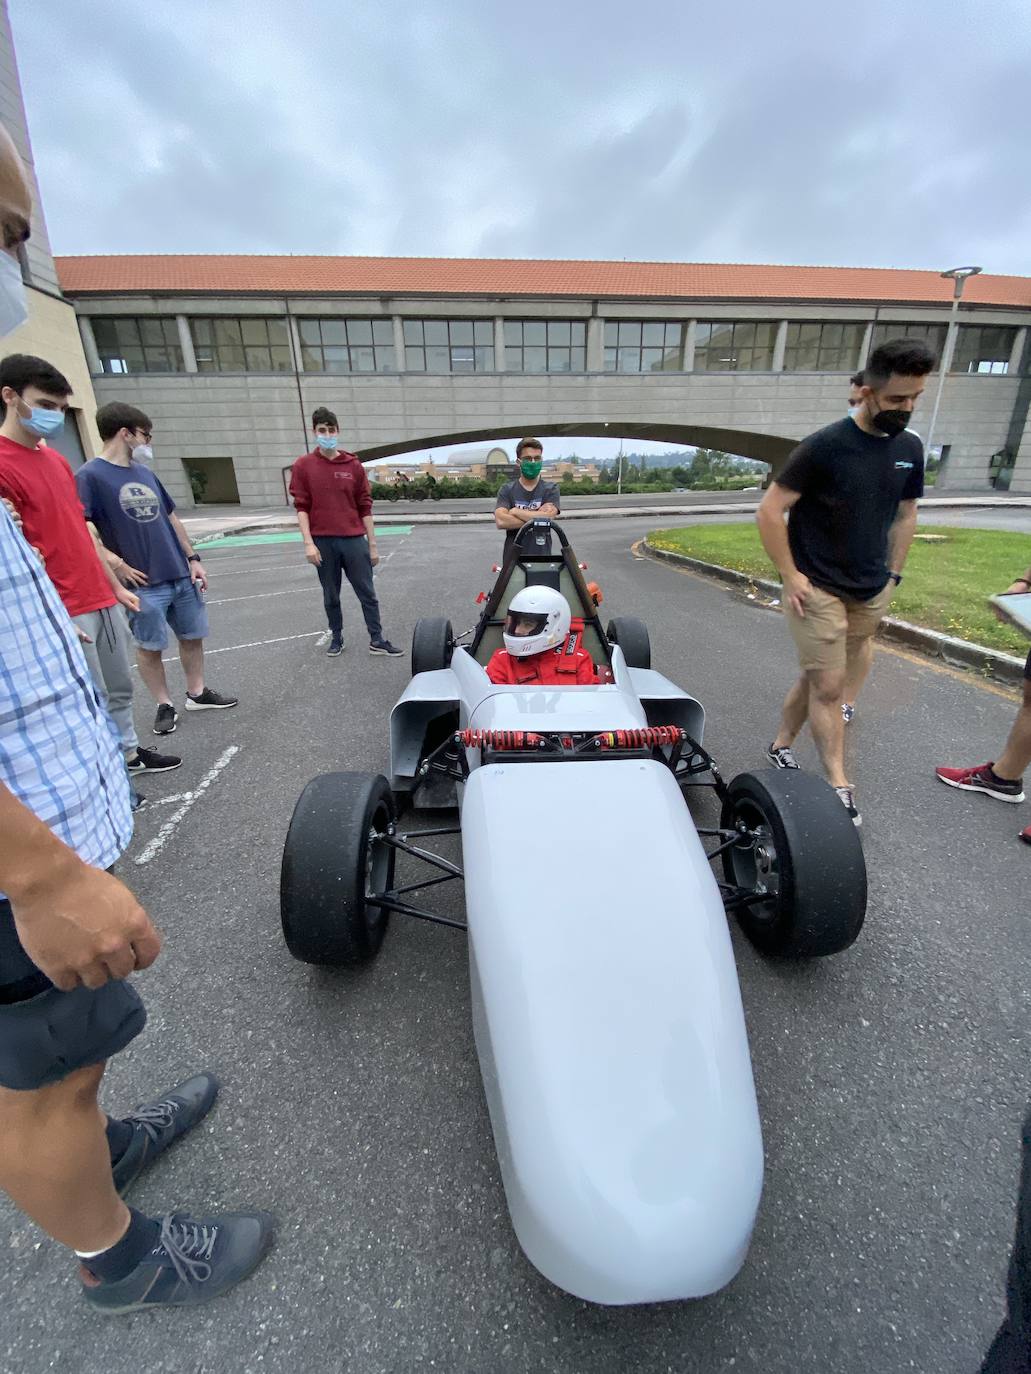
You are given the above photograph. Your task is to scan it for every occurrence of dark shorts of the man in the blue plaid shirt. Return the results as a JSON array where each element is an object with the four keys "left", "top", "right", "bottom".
[{"left": 0, "top": 899, "right": 147, "bottom": 1091}]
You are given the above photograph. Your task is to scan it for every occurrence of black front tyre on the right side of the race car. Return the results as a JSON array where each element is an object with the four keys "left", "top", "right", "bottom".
[{"left": 720, "top": 768, "right": 866, "bottom": 958}]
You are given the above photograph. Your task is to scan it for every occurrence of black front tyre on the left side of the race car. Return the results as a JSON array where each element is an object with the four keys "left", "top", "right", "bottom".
[{"left": 279, "top": 772, "right": 396, "bottom": 966}]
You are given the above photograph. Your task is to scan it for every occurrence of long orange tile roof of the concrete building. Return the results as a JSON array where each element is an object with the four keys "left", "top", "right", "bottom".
[{"left": 56, "top": 253, "right": 1031, "bottom": 308}]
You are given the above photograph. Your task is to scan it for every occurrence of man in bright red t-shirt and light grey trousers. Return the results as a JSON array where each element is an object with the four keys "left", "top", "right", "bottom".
[{"left": 0, "top": 353, "right": 181, "bottom": 774}]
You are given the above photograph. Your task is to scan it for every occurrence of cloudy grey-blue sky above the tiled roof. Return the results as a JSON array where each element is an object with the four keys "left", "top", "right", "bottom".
[{"left": 10, "top": 0, "right": 1031, "bottom": 275}]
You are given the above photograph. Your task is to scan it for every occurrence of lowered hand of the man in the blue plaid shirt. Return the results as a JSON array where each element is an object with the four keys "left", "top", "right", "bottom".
[{"left": 10, "top": 856, "right": 161, "bottom": 992}]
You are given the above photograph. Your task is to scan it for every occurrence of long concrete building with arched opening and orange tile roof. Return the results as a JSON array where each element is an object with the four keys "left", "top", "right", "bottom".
[{"left": 58, "top": 256, "right": 1031, "bottom": 506}]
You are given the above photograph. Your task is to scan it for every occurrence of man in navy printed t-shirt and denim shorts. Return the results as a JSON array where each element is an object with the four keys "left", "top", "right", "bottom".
[{"left": 76, "top": 401, "right": 238, "bottom": 735}]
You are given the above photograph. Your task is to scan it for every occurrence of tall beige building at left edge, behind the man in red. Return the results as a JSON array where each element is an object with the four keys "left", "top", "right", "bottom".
[{"left": 0, "top": 0, "right": 100, "bottom": 467}]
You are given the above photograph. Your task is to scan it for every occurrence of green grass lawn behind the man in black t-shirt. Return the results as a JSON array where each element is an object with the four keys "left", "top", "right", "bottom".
[{"left": 647, "top": 523, "right": 1031, "bottom": 657}]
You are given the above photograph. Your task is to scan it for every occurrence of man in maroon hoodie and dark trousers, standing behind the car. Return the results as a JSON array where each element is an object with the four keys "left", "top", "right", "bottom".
[{"left": 290, "top": 405, "right": 404, "bottom": 658}]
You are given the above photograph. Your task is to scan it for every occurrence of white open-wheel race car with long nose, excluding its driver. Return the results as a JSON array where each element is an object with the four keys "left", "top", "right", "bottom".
[{"left": 280, "top": 519, "right": 866, "bottom": 1304}]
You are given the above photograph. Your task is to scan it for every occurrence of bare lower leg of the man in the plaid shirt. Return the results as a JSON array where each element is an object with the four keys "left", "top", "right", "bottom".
[{"left": 0, "top": 1063, "right": 129, "bottom": 1253}]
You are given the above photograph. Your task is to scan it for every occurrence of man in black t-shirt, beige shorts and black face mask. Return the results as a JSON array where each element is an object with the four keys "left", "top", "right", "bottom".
[{"left": 756, "top": 339, "right": 935, "bottom": 826}]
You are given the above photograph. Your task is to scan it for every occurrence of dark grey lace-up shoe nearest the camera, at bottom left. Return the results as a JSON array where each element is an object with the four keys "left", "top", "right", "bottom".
[{"left": 80, "top": 1212, "right": 275, "bottom": 1316}]
